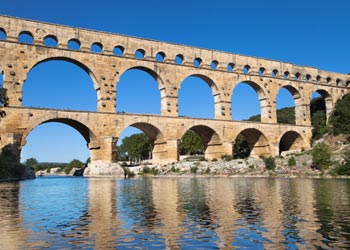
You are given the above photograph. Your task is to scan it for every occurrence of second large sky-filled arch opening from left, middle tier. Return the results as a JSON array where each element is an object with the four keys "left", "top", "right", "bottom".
[{"left": 117, "top": 67, "right": 160, "bottom": 114}]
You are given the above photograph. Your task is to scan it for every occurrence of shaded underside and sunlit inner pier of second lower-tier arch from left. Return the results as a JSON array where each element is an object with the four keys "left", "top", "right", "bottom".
[{"left": 118, "top": 122, "right": 167, "bottom": 162}]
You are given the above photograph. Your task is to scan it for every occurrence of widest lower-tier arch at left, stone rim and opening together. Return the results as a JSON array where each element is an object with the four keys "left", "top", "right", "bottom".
[{"left": 20, "top": 117, "right": 96, "bottom": 162}]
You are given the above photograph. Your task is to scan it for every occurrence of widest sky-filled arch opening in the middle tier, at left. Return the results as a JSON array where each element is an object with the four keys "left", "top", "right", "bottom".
[{"left": 22, "top": 58, "right": 97, "bottom": 111}]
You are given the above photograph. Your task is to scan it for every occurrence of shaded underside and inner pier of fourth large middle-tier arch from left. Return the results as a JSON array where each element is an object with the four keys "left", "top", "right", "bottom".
[{"left": 231, "top": 80, "right": 269, "bottom": 122}]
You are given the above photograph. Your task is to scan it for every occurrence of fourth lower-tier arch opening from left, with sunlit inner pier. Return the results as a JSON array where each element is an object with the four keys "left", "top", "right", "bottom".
[{"left": 233, "top": 128, "right": 271, "bottom": 158}]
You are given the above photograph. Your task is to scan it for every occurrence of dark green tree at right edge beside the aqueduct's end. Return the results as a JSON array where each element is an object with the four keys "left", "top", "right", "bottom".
[{"left": 330, "top": 94, "right": 350, "bottom": 135}]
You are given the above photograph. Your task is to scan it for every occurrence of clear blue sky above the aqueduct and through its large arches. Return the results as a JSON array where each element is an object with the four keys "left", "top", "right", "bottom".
[{"left": 0, "top": 0, "right": 350, "bottom": 162}]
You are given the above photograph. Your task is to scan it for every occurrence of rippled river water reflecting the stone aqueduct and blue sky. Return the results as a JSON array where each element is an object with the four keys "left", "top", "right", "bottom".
[{"left": 0, "top": 177, "right": 350, "bottom": 249}]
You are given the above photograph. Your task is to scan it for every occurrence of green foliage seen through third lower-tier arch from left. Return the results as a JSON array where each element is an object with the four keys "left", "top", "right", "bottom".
[{"left": 180, "top": 130, "right": 204, "bottom": 155}]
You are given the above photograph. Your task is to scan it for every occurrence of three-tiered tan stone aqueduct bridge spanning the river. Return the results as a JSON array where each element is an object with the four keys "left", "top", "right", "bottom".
[{"left": 0, "top": 16, "right": 350, "bottom": 162}]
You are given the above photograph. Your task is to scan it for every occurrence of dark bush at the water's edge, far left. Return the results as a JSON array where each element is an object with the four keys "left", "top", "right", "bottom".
[{"left": 0, "top": 147, "right": 26, "bottom": 179}]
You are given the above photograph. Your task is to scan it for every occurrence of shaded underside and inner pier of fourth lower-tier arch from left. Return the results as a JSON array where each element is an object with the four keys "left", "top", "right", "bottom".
[{"left": 234, "top": 128, "right": 271, "bottom": 158}]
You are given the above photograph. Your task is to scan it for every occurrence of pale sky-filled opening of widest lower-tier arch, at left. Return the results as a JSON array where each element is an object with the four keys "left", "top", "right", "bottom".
[{"left": 21, "top": 122, "right": 90, "bottom": 166}]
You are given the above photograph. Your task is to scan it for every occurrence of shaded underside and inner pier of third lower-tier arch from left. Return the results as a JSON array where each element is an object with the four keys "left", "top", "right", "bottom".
[{"left": 181, "top": 125, "right": 223, "bottom": 160}]
